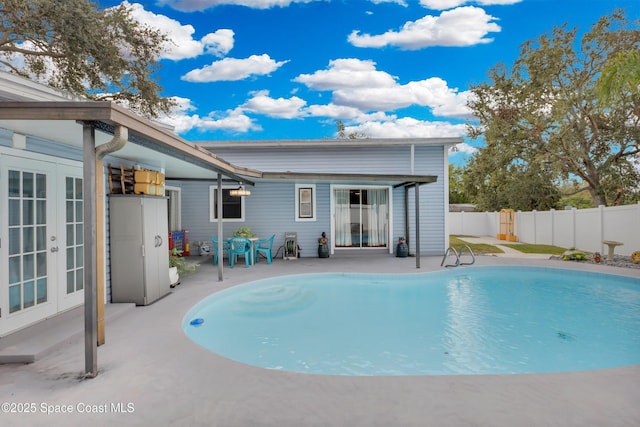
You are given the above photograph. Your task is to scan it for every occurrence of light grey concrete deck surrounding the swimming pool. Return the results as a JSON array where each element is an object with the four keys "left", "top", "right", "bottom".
[{"left": 0, "top": 252, "right": 640, "bottom": 427}]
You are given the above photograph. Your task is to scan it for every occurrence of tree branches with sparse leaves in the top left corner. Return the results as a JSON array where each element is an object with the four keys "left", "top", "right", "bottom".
[{"left": 0, "top": 0, "right": 174, "bottom": 117}]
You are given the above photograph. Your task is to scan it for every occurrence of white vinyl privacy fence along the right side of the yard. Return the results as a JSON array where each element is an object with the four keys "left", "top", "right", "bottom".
[{"left": 449, "top": 203, "right": 640, "bottom": 256}]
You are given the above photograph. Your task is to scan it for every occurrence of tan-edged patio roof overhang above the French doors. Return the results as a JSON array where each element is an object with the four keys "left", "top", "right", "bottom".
[{"left": 0, "top": 101, "right": 261, "bottom": 184}]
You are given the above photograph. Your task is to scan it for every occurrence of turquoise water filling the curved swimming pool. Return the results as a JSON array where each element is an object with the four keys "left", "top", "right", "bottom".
[{"left": 183, "top": 267, "right": 640, "bottom": 375}]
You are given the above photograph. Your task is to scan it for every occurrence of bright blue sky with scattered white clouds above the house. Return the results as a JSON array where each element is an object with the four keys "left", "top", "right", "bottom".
[{"left": 98, "top": 0, "right": 640, "bottom": 165}]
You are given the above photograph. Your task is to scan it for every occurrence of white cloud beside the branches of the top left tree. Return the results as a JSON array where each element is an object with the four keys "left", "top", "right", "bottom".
[{"left": 123, "top": 1, "right": 234, "bottom": 60}]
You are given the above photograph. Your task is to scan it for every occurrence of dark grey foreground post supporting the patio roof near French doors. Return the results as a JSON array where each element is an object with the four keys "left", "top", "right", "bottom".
[{"left": 82, "top": 122, "right": 98, "bottom": 378}]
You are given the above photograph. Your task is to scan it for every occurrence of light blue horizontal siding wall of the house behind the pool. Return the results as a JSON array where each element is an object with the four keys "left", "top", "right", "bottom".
[{"left": 178, "top": 144, "right": 446, "bottom": 257}]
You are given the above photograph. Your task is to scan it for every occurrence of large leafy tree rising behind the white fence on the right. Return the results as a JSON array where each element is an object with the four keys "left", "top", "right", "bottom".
[{"left": 469, "top": 11, "right": 640, "bottom": 205}]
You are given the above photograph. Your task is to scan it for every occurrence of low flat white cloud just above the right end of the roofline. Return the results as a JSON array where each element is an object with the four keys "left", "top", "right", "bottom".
[{"left": 345, "top": 117, "right": 466, "bottom": 138}]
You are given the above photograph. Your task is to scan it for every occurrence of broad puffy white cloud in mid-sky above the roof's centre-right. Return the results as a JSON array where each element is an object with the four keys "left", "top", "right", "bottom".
[{"left": 294, "top": 59, "right": 470, "bottom": 117}]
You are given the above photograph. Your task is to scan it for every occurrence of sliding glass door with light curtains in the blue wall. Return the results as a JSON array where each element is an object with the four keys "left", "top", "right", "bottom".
[{"left": 334, "top": 188, "right": 389, "bottom": 248}]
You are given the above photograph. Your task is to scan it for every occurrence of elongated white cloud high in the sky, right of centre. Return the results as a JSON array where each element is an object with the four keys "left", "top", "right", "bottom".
[{"left": 348, "top": 6, "right": 501, "bottom": 50}]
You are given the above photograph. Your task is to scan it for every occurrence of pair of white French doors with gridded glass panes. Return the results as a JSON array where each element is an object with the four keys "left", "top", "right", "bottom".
[{"left": 0, "top": 155, "right": 84, "bottom": 336}]
